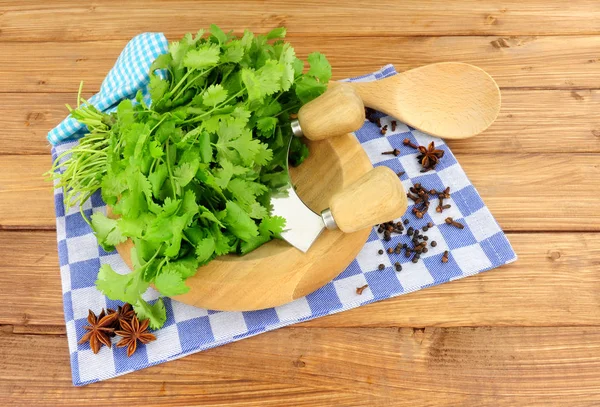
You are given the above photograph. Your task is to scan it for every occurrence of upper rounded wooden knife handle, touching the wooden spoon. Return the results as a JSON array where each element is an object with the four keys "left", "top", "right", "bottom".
[{"left": 298, "top": 83, "right": 365, "bottom": 140}]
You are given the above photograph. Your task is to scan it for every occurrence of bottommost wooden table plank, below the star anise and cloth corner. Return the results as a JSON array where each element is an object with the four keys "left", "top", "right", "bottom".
[{"left": 0, "top": 327, "right": 600, "bottom": 406}]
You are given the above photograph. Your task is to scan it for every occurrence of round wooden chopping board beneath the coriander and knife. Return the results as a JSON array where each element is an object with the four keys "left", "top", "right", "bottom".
[{"left": 117, "top": 134, "right": 372, "bottom": 311}]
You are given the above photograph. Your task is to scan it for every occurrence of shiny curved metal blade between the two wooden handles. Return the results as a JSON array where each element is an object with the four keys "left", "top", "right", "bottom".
[{"left": 271, "top": 138, "right": 325, "bottom": 253}]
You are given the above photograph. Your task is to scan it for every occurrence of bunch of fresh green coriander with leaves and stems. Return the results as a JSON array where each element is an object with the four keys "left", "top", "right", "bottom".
[{"left": 51, "top": 25, "right": 331, "bottom": 328}]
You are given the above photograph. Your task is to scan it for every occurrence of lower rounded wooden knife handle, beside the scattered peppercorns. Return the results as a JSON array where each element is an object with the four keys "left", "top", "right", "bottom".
[{"left": 329, "top": 167, "right": 408, "bottom": 233}]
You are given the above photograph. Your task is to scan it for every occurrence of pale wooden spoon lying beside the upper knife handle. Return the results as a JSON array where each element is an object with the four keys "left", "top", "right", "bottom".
[{"left": 332, "top": 62, "right": 500, "bottom": 139}]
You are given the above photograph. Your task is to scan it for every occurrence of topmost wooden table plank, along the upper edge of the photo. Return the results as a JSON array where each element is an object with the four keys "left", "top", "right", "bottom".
[{"left": 0, "top": 0, "right": 600, "bottom": 41}]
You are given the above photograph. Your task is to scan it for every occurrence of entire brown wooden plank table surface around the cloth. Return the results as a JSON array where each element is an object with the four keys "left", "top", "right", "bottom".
[{"left": 0, "top": 0, "right": 600, "bottom": 406}]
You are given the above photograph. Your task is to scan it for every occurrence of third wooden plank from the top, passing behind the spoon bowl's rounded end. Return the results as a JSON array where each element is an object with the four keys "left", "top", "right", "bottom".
[{"left": 0, "top": 89, "right": 600, "bottom": 155}]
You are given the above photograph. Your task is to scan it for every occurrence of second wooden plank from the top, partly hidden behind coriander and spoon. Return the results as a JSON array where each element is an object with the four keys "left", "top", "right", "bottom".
[{"left": 0, "top": 36, "right": 600, "bottom": 93}]
